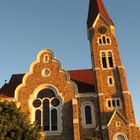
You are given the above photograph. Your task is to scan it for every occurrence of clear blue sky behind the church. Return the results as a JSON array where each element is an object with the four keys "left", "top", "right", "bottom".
[{"left": 0, "top": 0, "right": 140, "bottom": 124}]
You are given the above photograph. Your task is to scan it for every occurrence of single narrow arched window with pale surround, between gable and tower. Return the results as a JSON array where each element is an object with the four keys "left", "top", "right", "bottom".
[{"left": 81, "top": 102, "right": 96, "bottom": 128}]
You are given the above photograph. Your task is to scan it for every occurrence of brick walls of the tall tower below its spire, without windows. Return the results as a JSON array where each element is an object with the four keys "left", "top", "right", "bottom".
[{"left": 88, "top": 9, "right": 140, "bottom": 140}]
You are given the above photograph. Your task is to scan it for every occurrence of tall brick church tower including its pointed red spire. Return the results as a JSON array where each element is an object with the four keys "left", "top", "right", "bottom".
[{"left": 87, "top": 0, "right": 140, "bottom": 140}]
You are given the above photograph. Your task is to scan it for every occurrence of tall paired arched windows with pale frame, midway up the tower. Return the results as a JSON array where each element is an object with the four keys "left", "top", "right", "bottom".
[{"left": 101, "top": 50, "right": 114, "bottom": 68}]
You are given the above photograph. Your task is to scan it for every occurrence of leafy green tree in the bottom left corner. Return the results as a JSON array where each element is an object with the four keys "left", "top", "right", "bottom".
[{"left": 0, "top": 101, "right": 40, "bottom": 140}]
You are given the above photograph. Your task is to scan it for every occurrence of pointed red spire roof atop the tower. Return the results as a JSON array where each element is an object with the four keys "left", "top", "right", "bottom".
[{"left": 87, "top": 0, "right": 114, "bottom": 28}]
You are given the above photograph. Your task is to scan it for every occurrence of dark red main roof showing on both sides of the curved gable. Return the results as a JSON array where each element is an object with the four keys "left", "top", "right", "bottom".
[{"left": 0, "top": 69, "right": 95, "bottom": 98}]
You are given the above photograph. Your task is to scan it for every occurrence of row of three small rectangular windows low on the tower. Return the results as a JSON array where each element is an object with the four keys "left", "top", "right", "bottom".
[{"left": 107, "top": 98, "right": 122, "bottom": 109}]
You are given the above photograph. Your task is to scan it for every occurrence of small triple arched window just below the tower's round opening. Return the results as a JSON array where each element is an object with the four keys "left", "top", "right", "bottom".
[{"left": 97, "top": 35, "right": 111, "bottom": 45}]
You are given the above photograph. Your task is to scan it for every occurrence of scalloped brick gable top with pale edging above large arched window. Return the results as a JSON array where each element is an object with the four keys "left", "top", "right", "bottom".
[{"left": 14, "top": 50, "right": 77, "bottom": 108}]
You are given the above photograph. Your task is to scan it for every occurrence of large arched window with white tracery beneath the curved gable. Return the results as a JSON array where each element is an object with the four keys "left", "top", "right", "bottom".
[{"left": 33, "top": 88, "right": 61, "bottom": 131}]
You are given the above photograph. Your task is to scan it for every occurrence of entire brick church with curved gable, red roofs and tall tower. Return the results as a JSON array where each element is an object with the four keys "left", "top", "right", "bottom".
[{"left": 0, "top": 0, "right": 140, "bottom": 140}]
